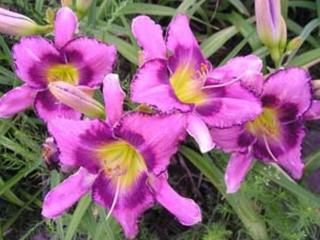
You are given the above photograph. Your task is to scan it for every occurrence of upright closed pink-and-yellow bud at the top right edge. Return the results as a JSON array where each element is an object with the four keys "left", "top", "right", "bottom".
[{"left": 255, "top": 0, "right": 287, "bottom": 49}]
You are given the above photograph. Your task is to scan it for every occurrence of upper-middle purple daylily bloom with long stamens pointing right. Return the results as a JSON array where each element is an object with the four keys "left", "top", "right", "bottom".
[{"left": 131, "top": 15, "right": 262, "bottom": 152}]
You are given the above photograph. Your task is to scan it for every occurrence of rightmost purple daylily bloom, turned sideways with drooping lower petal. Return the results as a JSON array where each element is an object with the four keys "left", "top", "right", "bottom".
[{"left": 211, "top": 68, "right": 320, "bottom": 193}]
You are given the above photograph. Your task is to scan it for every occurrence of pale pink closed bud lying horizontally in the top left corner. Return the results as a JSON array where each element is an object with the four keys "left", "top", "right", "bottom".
[{"left": 0, "top": 8, "right": 52, "bottom": 36}]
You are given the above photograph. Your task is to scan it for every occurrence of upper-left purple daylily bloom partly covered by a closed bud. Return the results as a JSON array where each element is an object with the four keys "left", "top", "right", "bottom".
[{"left": 0, "top": 7, "right": 116, "bottom": 121}]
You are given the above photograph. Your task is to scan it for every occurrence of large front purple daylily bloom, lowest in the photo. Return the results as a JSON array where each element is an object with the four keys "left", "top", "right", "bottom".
[{"left": 42, "top": 75, "right": 201, "bottom": 239}]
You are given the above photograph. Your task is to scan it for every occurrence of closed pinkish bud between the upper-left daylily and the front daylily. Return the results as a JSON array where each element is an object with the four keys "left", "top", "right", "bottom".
[{"left": 49, "top": 82, "right": 105, "bottom": 118}]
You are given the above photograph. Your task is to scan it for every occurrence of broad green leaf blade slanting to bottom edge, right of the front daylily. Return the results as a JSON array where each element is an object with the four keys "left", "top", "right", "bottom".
[{"left": 180, "top": 146, "right": 269, "bottom": 240}]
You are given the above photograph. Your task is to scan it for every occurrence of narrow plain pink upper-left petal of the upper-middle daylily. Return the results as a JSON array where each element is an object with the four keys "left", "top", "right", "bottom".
[{"left": 131, "top": 16, "right": 167, "bottom": 65}]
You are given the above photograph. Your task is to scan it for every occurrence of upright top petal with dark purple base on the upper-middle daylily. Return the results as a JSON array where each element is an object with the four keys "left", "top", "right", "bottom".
[{"left": 167, "top": 14, "right": 208, "bottom": 72}]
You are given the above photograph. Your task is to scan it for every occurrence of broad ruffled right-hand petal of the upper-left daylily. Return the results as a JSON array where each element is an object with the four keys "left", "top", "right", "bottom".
[{"left": 61, "top": 37, "right": 116, "bottom": 87}]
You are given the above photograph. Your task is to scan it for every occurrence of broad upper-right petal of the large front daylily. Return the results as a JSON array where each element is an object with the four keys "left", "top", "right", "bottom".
[{"left": 115, "top": 112, "right": 187, "bottom": 174}]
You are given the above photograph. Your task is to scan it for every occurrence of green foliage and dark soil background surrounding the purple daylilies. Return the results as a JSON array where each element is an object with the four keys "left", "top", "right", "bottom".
[{"left": 0, "top": 0, "right": 320, "bottom": 240}]
